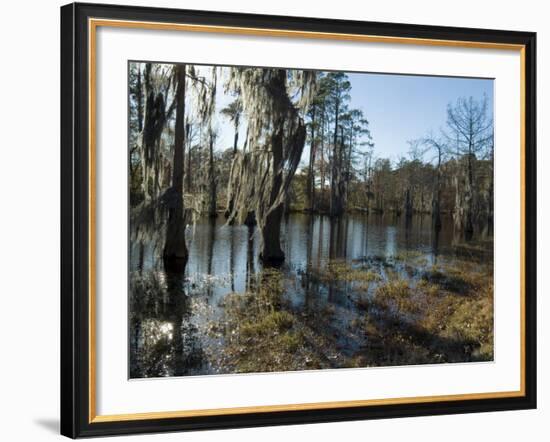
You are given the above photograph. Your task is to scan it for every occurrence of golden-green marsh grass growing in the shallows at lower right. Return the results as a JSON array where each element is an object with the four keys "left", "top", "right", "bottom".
[{"left": 208, "top": 253, "right": 493, "bottom": 372}]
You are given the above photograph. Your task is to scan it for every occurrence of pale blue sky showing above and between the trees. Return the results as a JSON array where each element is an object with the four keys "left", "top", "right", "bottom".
[{"left": 212, "top": 73, "right": 493, "bottom": 165}]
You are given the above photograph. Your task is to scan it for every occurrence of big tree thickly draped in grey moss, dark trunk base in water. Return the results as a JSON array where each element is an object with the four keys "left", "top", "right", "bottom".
[{"left": 226, "top": 68, "right": 316, "bottom": 264}]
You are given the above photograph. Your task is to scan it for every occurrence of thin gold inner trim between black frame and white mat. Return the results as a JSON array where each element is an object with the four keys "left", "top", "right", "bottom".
[{"left": 88, "top": 18, "right": 526, "bottom": 423}]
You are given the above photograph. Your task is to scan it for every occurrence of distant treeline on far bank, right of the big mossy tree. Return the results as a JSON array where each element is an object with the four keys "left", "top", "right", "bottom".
[{"left": 289, "top": 153, "right": 493, "bottom": 233}]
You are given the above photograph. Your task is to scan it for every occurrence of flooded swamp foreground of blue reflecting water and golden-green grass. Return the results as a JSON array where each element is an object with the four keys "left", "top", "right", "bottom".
[{"left": 129, "top": 214, "right": 492, "bottom": 378}]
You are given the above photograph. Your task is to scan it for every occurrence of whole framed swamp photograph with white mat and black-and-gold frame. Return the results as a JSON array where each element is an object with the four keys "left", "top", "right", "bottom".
[{"left": 61, "top": 4, "right": 536, "bottom": 438}]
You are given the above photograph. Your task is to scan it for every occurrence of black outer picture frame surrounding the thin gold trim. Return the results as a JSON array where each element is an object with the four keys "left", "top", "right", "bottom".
[{"left": 60, "top": 3, "right": 537, "bottom": 438}]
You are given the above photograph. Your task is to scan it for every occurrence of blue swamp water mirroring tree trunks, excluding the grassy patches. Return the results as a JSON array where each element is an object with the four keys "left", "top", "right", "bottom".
[{"left": 129, "top": 214, "right": 492, "bottom": 378}]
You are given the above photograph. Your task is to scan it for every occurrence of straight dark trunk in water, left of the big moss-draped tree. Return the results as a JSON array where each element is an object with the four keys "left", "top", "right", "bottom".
[{"left": 163, "top": 65, "right": 188, "bottom": 270}]
